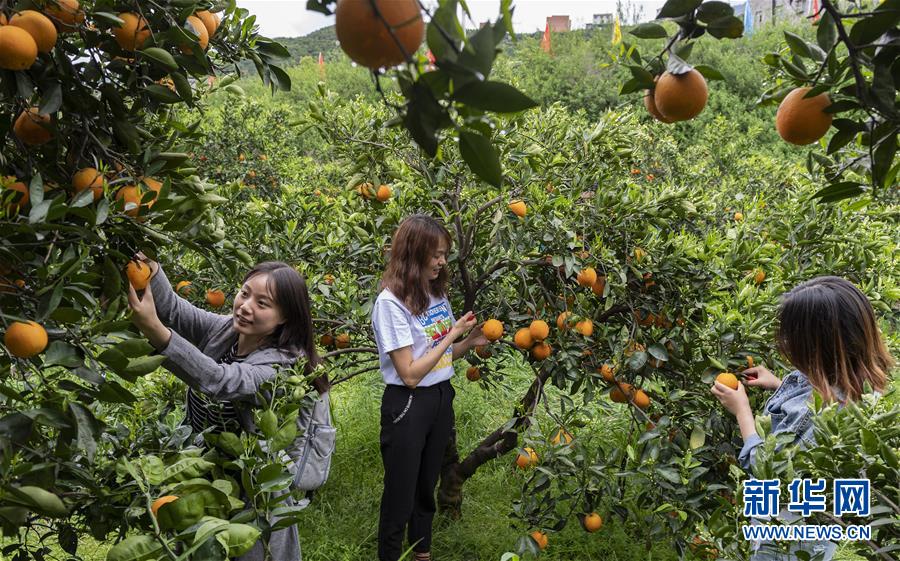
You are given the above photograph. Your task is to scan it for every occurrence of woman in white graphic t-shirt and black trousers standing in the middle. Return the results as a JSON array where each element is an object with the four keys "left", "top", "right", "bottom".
[{"left": 372, "top": 214, "right": 488, "bottom": 561}]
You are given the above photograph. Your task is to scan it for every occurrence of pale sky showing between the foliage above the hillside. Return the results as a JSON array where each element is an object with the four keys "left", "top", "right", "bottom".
[{"left": 237, "top": 0, "right": 663, "bottom": 37}]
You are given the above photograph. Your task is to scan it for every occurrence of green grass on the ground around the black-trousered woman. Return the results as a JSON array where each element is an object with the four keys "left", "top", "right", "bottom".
[{"left": 300, "top": 368, "right": 677, "bottom": 561}]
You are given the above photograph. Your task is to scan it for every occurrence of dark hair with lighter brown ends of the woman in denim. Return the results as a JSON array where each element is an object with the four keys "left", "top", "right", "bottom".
[{"left": 777, "top": 276, "right": 894, "bottom": 401}]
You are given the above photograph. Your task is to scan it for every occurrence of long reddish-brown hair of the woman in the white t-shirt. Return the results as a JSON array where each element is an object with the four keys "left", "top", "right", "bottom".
[{"left": 381, "top": 214, "right": 453, "bottom": 315}]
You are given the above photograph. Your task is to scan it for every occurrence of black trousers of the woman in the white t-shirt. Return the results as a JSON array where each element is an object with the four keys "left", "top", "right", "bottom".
[{"left": 378, "top": 382, "right": 456, "bottom": 561}]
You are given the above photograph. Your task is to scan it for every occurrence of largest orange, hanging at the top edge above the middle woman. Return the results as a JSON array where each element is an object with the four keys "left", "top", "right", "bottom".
[{"left": 334, "top": 0, "right": 425, "bottom": 69}]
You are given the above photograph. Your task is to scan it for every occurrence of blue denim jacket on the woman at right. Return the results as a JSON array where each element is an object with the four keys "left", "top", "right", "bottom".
[{"left": 738, "top": 370, "right": 815, "bottom": 470}]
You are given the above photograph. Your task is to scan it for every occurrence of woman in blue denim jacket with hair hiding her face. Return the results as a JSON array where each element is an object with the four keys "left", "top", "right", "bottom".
[{"left": 712, "top": 276, "right": 893, "bottom": 561}]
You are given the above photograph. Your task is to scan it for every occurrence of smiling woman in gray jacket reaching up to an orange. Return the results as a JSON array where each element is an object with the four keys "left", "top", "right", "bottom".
[{"left": 128, "top": 260, "right": 319, "bottom": 561}]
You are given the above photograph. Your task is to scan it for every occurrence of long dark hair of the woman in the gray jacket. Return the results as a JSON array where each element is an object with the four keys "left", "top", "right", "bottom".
[{"left": 242, "top": 261, "right": 319, "bottom": 372}]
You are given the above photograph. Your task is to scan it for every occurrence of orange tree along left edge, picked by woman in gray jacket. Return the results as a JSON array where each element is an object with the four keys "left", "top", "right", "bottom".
[{"left": 0, "top": 0, "right": 324, "bottom": 559}]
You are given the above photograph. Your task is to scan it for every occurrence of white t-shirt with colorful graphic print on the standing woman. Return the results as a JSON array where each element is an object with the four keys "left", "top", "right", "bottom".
[{"left": 372, "top": 289, "right": 456, "bottom": 387}]
